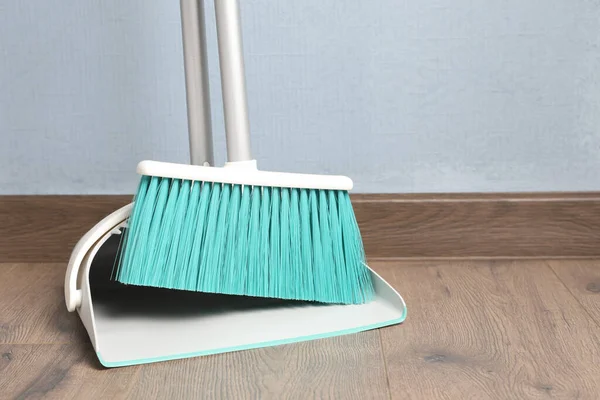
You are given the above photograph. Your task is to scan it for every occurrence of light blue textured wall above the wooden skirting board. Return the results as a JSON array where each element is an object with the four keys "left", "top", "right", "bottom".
[{"left": 0, "top": 0, "right": 600, "bottom": 194}]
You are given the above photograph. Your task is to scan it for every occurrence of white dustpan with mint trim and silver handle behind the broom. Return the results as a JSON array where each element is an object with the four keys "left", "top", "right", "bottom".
[{"left": 65, "top": 0, "right": 406, "bottom": 367}]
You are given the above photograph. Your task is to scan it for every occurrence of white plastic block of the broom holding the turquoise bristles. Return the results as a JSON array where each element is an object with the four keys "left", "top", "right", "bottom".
[{"left": 137, "top": 160, "right": 353, "bottom": 191}]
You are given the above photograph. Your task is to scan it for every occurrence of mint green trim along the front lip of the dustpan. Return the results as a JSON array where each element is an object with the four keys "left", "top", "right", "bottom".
[{"left": 96, "top": 308, "right": 407, "bottom": 368}]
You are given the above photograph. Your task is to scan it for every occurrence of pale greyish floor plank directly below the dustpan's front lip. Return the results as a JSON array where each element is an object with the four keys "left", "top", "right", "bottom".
[{"left": 132, "top": 331, "right": 389, "bottom": 399}]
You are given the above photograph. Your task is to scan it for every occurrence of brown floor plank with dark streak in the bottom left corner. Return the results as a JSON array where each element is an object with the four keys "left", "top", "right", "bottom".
[{"left": 0, "top": 343, "right": 140, "bottom": 399}]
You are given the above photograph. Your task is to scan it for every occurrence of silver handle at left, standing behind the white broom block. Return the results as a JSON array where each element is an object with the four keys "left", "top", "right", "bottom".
[{"left": 180, "top": 0, "right": 214, "bottom": 165}]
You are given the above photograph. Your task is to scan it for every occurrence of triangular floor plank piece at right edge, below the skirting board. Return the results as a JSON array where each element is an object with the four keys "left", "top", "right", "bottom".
[{"left": 548, "top": 260, "right": 600, "bottom": 326}]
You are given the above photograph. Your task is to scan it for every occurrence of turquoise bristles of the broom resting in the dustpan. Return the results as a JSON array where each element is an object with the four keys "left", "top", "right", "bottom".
[{"left": 115, "top": 176, "right": 374, "bottom": 304}]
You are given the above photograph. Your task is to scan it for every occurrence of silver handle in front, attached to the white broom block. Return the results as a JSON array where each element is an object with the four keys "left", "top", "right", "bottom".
[{"left": 215, "top": 0, "right": 252, "bottom": 163}]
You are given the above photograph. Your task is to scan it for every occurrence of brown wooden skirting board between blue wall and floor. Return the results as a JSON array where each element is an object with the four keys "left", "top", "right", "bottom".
[{"left": 0, "top": 192, "right": 600, "bottom": 262}]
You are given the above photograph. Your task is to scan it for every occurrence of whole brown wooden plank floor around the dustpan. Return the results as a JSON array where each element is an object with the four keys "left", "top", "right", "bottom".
[{"left": 0, "top": 260, "right": 600, "bottom": 399}]
